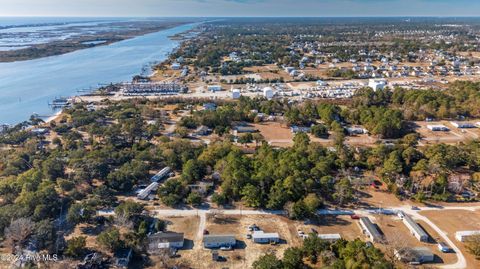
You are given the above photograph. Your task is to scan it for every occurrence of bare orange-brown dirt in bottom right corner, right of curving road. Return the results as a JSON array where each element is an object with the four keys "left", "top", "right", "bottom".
[{"left": 420, "top": 210, "right": 480, "bottom": 269}]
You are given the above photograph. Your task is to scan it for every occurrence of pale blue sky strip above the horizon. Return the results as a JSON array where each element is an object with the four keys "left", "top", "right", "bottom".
[{"left": 0, "top": 0, "right": 480, "bottom": 17}]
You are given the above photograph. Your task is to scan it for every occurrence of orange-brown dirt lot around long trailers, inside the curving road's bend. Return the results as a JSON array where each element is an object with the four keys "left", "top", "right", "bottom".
[{"left": 372, "top": 215, "right": 456, "bottom": 264}]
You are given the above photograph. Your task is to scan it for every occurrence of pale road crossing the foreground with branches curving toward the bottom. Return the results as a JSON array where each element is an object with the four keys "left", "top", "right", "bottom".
[{"left": 152, "top": 205, "right": 480, "bottom": 269}]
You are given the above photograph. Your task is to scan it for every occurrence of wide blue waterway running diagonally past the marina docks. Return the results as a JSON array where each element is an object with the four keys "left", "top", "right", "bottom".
[{"left": 0, "top": 21, "right": 198, "bottom": 124}]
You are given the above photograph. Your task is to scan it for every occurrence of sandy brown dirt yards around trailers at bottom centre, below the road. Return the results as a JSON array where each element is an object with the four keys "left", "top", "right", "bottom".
[{"left": 154, "top": 213, "right": 370, "bottom": 268}]
